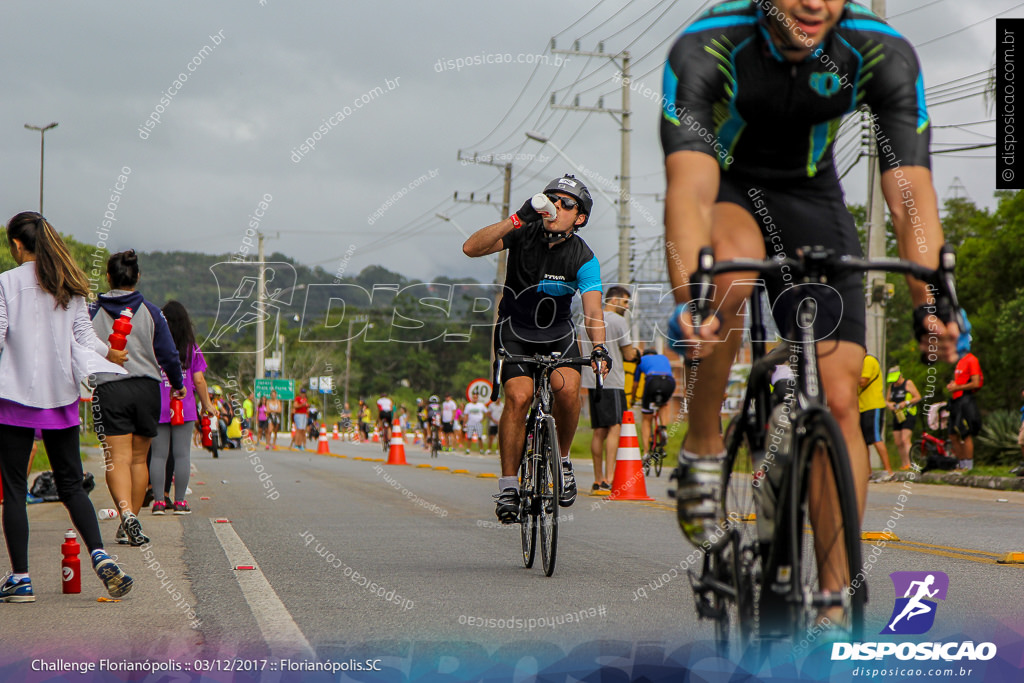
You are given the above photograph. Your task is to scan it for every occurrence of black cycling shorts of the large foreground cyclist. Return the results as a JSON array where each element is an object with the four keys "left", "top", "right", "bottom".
[{"left": 716, "top": 172, "right": 866, "bottom": 346}]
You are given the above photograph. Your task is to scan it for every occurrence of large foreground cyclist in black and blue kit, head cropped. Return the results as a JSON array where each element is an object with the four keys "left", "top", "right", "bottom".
[{"left": 660, "top": 0, "right": 958, "bottom": 618}]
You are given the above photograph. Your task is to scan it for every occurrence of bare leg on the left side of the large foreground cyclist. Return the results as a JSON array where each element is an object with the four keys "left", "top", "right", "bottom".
[{"left": 670, "top": 203, "right": 765, "bottom": 456}]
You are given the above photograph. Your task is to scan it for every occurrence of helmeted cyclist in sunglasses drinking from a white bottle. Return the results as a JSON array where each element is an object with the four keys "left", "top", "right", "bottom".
[{"left": 462, "top": 175, "right": 609, "bottom": 524}]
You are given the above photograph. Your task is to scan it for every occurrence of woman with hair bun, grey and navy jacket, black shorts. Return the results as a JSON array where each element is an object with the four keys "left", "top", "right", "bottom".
[{"left": 89, "top": 250, "right": 185, "bottom": 546}]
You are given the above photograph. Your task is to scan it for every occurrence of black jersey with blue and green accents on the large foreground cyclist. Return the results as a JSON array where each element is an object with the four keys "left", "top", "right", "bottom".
[{"left": 662, "top": 0, "right": 931, "bottom": 182}]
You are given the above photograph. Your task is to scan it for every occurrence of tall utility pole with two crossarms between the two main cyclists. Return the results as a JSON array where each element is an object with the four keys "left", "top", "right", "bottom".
[{"left": 551, "top": 38, "right": 633, "bottom": 286}]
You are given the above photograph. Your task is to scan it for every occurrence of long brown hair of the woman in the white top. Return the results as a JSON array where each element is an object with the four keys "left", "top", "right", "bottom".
[{"left": 7, "top": 211, "right": 89, "bottom": 310}]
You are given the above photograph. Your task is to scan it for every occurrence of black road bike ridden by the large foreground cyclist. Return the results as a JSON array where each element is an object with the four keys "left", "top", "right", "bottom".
[{"left": 673, "top": 246, "right": 963, "bottom": 656}]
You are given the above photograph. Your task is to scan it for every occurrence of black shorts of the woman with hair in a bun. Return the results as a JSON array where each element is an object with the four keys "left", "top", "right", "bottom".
[{"left": 92, "top": 377, "right": 160, "bottom": 437}]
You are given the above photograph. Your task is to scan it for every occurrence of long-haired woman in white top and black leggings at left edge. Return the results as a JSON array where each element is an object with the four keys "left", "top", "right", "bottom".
[{"left": 0, "top": 212, "right": 132, "bottom": 602}]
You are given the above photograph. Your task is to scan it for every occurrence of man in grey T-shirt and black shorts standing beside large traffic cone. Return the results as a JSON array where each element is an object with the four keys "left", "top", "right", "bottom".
[{"left": 581, "top": 285, "right": 638, "bottom": 492}]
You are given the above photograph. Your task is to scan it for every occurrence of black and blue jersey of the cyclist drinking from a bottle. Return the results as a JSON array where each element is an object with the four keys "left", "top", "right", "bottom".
[{"left": 498, "top": 220, "right": 601, "bottom": 342}]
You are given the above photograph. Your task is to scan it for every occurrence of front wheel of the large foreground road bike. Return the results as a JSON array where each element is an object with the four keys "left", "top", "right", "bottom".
[{"left": 779, "top": 412, "right": 867, "bottom": 644}]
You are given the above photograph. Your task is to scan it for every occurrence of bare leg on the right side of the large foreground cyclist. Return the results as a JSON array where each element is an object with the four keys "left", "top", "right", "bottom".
[{"left": 808, "top": 341, "right": 871, "bottom": 622}]
